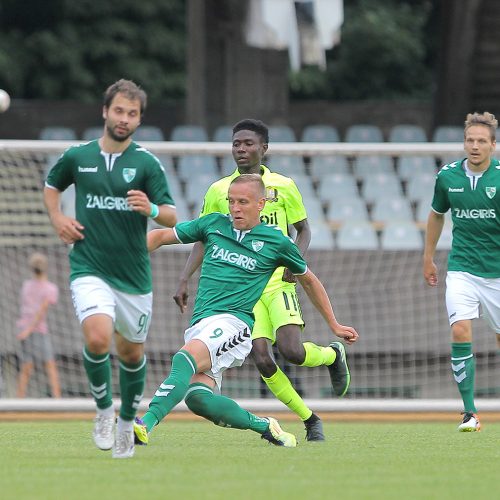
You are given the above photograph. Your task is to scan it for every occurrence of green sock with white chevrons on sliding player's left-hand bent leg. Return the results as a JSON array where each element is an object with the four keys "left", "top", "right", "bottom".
[{"left": 142, "top": 350, "right": 198, "bottom": 432}]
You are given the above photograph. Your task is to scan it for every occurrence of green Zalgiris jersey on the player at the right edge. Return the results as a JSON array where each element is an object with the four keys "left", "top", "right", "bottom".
[{"left": 432, "top": 159, "right": 500, "bottom": 278}]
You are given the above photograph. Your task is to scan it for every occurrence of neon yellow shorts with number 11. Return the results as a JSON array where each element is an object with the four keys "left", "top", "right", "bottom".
[{"left": 252, "top": 283, "right": 304, "bottom": 344}]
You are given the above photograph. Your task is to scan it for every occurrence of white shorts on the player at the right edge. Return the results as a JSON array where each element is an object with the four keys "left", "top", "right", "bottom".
[{"left": 446, "top": 271, "right": 500, "bottom": 334}]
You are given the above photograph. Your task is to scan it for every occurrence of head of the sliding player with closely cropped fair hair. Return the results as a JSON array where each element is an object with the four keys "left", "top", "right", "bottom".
[{"left": 228, "top": 174, "right": 266, "bottom": 231}]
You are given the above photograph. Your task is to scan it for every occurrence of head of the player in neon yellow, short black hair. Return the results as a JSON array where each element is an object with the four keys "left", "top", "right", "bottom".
[{"left": 232, "top": 118, "right": 269, "bottom": 173}]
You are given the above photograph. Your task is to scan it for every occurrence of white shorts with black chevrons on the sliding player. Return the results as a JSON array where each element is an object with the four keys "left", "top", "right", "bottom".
[{"left": 184, "top": 314, "right": 252, "bottom": 390}]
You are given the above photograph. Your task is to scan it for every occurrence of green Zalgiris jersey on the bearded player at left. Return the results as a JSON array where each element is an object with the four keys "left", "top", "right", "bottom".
[{"left": 46, "top": 141, "right": 174, "bottom": 294}]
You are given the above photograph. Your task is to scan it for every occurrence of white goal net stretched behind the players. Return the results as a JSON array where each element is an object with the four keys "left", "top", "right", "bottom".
[{"left": 0, "top": 141, "right": 500, "bottom": 410}]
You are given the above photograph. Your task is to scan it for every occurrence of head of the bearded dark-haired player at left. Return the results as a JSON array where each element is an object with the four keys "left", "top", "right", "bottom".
[{"left": 102, "top": 79, "right": 147, "bottom": 142}]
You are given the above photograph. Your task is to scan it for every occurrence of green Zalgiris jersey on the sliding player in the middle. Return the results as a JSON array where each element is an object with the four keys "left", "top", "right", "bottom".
[{"left": 175, "top": 213, "right": 307, "bottom": 328}]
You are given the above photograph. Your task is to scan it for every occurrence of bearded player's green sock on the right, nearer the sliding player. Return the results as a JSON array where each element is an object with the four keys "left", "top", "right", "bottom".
[{"left": 119, "top": 356, "right": 146, "bottom": 420}]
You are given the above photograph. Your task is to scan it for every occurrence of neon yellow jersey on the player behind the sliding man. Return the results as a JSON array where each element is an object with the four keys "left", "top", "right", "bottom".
[{"left": 200, "top": 165, "right": 307, "bottom": 293}]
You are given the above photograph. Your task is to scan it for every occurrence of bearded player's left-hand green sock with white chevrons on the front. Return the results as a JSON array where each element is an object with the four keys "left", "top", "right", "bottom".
[{"left": 83, "top": 346, "right": 112, "bottom": 412}]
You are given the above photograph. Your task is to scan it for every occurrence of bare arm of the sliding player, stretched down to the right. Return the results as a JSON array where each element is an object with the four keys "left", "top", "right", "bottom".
[{"left": 297, "top": 269, "right": 359, "bottom": 344}]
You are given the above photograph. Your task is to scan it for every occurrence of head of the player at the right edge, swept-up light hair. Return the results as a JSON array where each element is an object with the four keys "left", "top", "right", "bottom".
[{"left": 464, "top": 112, "right": 498, "bottom": 168}]
